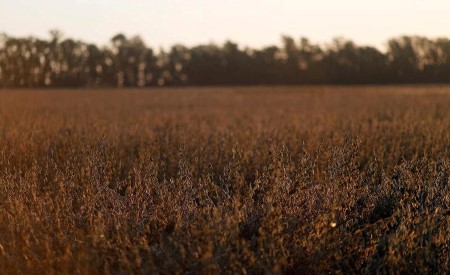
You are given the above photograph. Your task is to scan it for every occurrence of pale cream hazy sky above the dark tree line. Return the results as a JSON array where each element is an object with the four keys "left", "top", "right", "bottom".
[{"left": 0, "top": 0, "right": 450, "bottom": 48}]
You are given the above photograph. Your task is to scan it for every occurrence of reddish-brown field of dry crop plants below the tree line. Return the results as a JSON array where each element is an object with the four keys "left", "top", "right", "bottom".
[{"left": 0, "top": 86, "right": 450, "bottom": 274}]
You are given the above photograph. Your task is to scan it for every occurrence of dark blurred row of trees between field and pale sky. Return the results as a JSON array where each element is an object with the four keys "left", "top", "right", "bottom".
[{"left": 0, "top": 31, "right": 450, "bottom": 88}]
